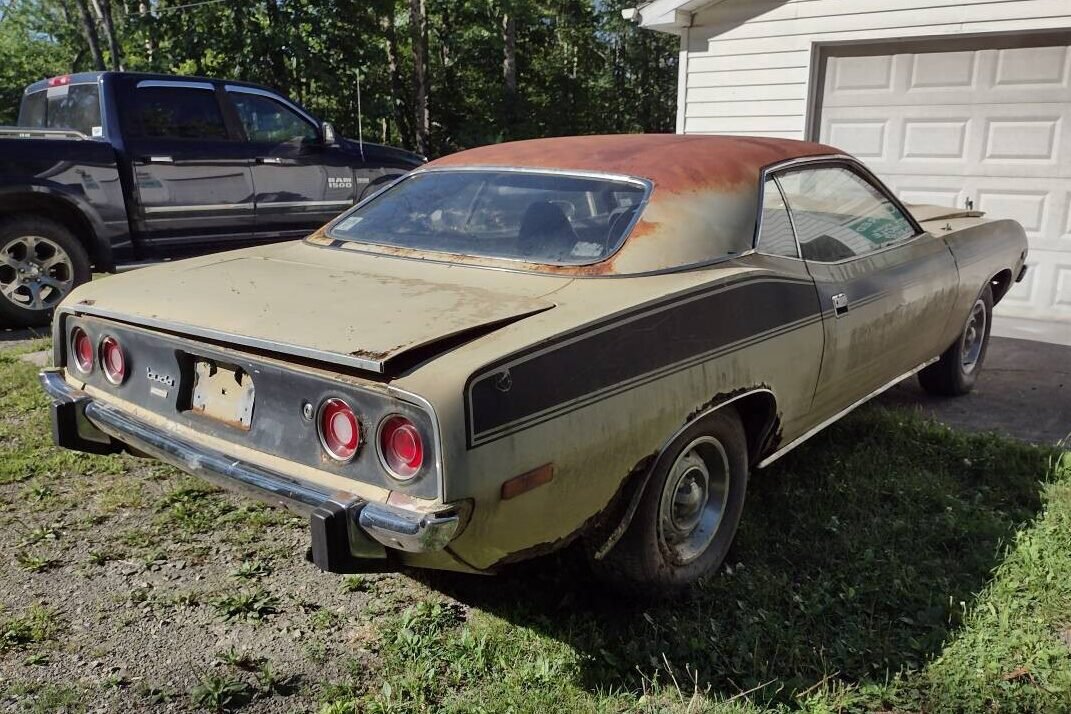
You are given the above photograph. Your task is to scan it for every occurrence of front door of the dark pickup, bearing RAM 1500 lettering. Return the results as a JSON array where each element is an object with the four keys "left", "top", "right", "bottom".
[{"left": 225, "top": 85, "right": 355, "bottom": 237}]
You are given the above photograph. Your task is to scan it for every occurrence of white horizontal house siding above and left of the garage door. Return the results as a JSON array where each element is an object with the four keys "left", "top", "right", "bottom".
[{"left": 677, "top": 0, "right": 1071, "bottom": 138}]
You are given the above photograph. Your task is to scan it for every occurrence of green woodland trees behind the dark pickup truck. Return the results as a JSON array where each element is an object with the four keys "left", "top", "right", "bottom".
[{"left": 0, "top": 0, "right": 677, "bottom": 155}]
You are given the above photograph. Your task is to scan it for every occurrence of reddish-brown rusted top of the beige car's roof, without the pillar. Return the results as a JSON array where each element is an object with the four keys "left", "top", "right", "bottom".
[{"left": 427, "top": 134, "right": 840, "bottom": 194}]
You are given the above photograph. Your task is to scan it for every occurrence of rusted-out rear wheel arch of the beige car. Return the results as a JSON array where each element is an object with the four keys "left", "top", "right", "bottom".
[{"left": 591, "top": 384, "right": 781, "bottom": 560}]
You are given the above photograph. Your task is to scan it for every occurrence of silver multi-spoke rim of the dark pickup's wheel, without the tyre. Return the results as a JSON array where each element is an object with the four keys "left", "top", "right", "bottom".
[{"left": 0, "top": 236, "right": 74, "bottom": 310}]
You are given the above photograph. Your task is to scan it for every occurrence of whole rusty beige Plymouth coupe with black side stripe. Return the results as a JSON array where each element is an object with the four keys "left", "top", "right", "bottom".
[{"left": 41, "top": 135, "right": 1026, "bottom": 592}]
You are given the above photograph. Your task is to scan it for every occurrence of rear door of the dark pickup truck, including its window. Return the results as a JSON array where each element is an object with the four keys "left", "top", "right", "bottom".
[{"left": 122, "top": 79, "right": 256, "bottom": 247}]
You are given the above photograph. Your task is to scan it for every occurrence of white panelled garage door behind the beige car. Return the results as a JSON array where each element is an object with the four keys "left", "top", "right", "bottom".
[{"left": 819, "top": 39, "right": 1071, "bottom": 344}]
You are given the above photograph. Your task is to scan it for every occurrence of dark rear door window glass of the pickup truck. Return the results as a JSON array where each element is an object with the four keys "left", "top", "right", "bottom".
[{"left": 134, "top": 87, "right": 228, "bottom": 139}]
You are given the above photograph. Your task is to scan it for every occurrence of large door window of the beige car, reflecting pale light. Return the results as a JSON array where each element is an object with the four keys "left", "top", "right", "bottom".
[{"left": 778, "top": 166, "right": 915, "bottom": 262}]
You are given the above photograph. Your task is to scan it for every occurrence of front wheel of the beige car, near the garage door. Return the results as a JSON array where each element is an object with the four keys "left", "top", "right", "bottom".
[{"left": 919, "top": 285, "right": 993, "bottom": 397}]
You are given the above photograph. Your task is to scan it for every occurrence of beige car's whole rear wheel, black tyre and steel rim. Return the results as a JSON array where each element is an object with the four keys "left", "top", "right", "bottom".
[{"left": 594, "top": 408, "right": 748, "bottom": 596}]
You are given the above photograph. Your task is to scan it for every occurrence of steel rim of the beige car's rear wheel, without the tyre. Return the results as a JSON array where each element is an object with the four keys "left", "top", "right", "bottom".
[{"left": 659, "top": 437, "right": 729, "bottom": 564}]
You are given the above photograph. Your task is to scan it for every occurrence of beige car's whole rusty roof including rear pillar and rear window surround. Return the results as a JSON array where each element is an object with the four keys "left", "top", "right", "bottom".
[{"left": 329, "top": 134, "right": 841, "bottom": 276}]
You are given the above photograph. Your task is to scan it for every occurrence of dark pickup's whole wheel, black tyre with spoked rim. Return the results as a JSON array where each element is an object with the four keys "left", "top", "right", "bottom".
[{"left": 0, "top": 216, "right": 91, "bottom": 326}]
